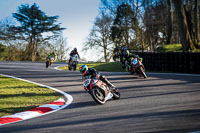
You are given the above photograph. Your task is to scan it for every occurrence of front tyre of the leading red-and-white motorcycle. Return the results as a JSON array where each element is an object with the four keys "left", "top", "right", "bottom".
[{"left": 90, "top": 88, "right": 106, "bottom": 105}]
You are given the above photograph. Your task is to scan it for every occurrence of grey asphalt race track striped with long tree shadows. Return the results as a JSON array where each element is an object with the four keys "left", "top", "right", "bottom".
[{"left": 0, "top": 62, "right": 200, "bottom": 133}]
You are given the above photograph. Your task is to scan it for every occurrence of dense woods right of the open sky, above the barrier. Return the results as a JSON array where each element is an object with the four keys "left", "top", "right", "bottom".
[{"left": 84, "top": 0, "right": 200, "bottom": 62}]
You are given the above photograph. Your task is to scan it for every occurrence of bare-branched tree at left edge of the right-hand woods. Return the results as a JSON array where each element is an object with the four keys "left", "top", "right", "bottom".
[{"left": 86, "top": 13, "right": 113, "bottom": 62}]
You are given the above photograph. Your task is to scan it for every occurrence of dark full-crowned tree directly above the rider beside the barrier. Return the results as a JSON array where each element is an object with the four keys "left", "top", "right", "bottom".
[{"left": 111, "top": 3, "right": 138, "bottom": 48}]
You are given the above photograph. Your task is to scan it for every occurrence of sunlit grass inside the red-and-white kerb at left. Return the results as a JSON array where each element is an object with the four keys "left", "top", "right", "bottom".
[{"left": 0, "top": 76, "right": 63, "bottom": 117}]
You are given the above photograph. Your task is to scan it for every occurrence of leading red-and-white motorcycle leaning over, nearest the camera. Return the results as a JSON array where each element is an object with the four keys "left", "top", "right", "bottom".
[{"left": 84, "top": 78, "right": 120, "bottom": 105}]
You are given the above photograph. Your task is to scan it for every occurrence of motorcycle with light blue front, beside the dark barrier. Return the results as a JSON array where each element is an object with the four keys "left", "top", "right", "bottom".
[{"left": 129, "top": 58, "right": 147, "bottom": 78}]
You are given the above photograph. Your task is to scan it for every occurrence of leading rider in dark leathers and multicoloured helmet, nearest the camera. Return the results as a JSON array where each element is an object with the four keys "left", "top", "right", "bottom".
[{"left": 79, "top": 65, "right": 116, "bottom": 90}]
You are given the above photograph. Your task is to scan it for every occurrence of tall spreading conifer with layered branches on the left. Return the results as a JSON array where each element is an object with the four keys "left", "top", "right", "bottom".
[{"left": 9, "top": 3, "right": 65, "bottom": 61}]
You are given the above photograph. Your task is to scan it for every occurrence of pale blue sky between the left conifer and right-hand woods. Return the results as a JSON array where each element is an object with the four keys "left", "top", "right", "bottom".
[{"left": 0, "top": 0, "right": 100, "bottom": 60}]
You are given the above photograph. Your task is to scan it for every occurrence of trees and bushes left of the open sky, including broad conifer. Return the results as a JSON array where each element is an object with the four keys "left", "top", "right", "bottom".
[{"left": 0, "top": 3, "right": 67, "bottom": 61}]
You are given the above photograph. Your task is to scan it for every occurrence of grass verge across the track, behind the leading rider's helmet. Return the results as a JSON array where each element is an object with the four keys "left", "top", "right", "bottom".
[{"left": 58, "top": 62, "right": 125, "bottom": 72}]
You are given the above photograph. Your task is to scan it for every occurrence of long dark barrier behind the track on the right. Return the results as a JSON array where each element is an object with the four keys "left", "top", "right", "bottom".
[{"left": 134, "top": 52, "right": 200, "bottom": 74}]
